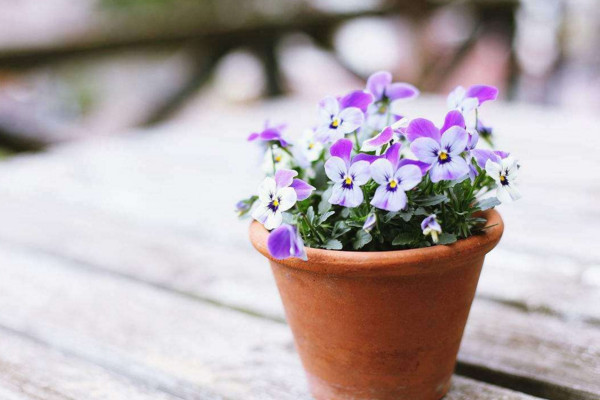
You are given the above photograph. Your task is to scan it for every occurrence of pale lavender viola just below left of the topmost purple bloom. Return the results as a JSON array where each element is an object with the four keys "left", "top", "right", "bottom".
[{"left": 315, "top": 96, "right": 365, "bottom": 143}]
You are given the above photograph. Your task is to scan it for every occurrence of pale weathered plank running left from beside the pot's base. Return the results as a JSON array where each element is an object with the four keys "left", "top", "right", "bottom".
[{"left": 0, "top": 246, "right": 533, "bottom": 400}]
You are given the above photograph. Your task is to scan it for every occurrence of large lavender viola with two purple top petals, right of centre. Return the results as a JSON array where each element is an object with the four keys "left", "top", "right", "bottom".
[{"left": 408, "top": 118, "right": 469, "bottom": 182}]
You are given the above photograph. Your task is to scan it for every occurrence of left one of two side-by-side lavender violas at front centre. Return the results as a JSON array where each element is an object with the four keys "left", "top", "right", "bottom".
[{"left": 325, "top": 139, "right": 371, "bottom": 207}]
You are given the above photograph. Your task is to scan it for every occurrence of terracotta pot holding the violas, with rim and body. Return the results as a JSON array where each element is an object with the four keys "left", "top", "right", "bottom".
[{"left": 250, "top": 210, "right": 504, "bottom": 400}]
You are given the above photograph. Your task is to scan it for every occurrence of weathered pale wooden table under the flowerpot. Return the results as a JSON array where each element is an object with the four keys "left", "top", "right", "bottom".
[{"left": 0, "top": 98, "right": 600, "bottom": 400}]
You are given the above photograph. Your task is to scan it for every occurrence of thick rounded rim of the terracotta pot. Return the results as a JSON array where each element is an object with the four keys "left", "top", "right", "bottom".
[{"left": 249, "top": 209, "right": 504, "bottom": 275}]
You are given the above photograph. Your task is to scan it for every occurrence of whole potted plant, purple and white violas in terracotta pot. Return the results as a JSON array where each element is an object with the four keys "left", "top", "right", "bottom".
[{"left": 237, "top": 72, "right": 520, "bottom": 400}]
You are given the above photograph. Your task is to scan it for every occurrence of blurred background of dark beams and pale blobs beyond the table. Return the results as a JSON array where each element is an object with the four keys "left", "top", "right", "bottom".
[{"left": 0, "top": 0, "right": 600, "bottom": 157}]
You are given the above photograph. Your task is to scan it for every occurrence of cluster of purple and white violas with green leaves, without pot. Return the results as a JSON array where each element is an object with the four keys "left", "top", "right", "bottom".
[{"left": 236, "top": 72, "right": 520, "bottom": 260}]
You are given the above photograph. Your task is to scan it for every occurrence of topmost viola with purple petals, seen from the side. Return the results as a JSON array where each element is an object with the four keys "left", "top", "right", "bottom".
[{"left": 367, "top": 71, "right": 419, "bottom": 130}]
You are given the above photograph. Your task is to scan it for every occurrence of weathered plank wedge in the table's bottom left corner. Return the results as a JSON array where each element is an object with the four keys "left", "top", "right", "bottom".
[{"left": 0, "top": 329, "right": 176, "bottom": 400}]
